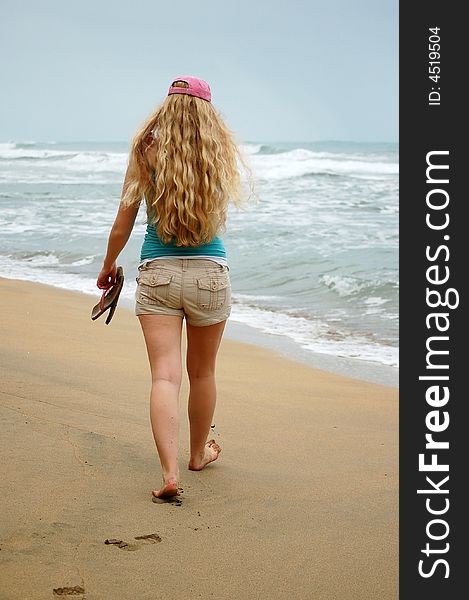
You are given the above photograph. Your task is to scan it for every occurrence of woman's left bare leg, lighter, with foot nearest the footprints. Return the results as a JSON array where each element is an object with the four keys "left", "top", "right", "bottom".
[{"left": 139, "top": 315, "right": 182, "bottom": 498}]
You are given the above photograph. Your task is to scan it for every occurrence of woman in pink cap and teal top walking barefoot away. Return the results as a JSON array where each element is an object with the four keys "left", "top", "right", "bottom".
[{"left": 97, "top": 76, "right": 252, "bottom": 498}]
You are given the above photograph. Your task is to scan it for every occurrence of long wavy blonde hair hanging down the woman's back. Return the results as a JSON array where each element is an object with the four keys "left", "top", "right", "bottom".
[{"left": 121, "top": 80, "right": 255, "bottom": 246}]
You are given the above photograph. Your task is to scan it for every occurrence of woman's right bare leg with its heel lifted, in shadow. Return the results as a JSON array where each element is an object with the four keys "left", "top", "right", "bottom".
[{"left": 187, "top": 321, "right": 226, "bottom": 471}]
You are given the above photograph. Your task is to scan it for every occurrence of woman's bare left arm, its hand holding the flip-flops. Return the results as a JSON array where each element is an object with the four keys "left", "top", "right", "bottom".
[{"left": 96, "top": 169, "right": 140, "bottom": 289}]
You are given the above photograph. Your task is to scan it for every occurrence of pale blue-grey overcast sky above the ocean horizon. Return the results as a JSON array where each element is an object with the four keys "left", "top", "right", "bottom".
[{"left": 0, "top": 0, "right": 398, "bottom": 142}]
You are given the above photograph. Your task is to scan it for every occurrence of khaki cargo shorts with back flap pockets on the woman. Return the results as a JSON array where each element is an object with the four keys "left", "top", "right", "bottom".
[{"left": 135, "top": 258, "right": 231, "bottom": 327}]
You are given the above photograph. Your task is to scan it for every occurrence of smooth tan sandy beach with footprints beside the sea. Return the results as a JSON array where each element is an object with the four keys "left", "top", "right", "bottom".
[{"left": 0, "top": 279, "right": 398, "bottom": 600}]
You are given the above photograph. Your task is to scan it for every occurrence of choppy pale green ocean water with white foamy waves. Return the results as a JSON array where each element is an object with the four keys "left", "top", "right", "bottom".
[{"left": 0, "top": 141, "right": 399, "bottom": 367}]
